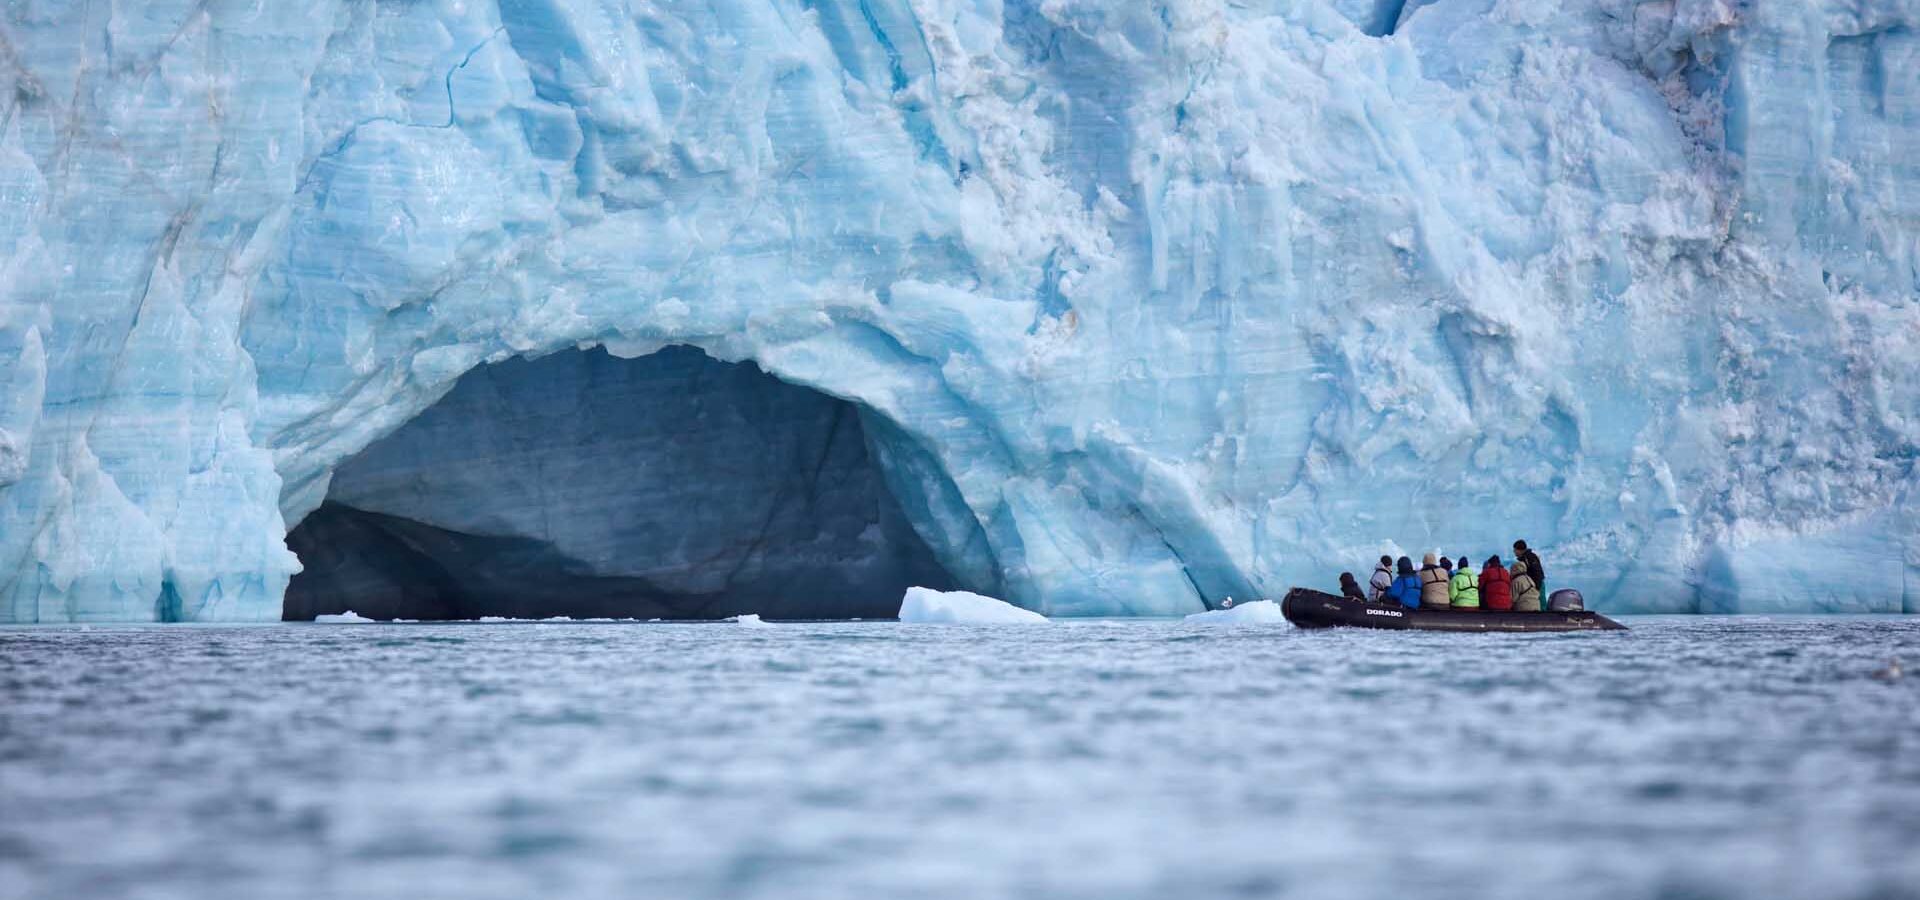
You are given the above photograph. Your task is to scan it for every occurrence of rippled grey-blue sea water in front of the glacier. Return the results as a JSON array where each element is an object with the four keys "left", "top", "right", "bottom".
[{"left": 0, "top": 618, "right": 1920, "bottom": 900}]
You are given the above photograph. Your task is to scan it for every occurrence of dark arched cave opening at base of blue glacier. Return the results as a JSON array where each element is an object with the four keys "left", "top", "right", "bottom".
[{"left": 282, "top": 345, "right": 962, "bottom": 620}]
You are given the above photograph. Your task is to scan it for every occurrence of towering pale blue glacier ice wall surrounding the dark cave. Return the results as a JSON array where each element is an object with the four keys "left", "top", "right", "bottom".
[{"left": 0, "top": 0, "right": 1920, "bottom": 622}]
